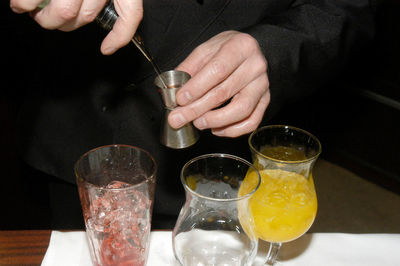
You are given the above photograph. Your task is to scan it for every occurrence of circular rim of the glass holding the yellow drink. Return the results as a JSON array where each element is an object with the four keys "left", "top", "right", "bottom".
[{"left": 248, "top": 125, "right": 322, "bottom": 164}]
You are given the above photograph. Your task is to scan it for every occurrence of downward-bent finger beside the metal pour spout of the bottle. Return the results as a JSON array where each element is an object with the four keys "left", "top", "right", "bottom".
[{"left": 100, "top": 0, "right": 143, "bottom": 55}]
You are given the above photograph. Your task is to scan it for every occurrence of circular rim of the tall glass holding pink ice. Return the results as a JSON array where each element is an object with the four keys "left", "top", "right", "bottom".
[{"left": 74, "top": 144, "right": 157, "bottom": 191}]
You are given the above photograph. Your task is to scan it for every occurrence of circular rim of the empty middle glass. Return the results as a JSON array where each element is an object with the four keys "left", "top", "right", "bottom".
[{"left": 181, "top": 153, "right": 261, "bottom": 202}]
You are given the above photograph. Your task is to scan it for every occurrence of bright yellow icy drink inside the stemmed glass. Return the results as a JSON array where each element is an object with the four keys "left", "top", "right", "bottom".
[{"left": 239, "top": 169, "right": 317, "bottom": 242}]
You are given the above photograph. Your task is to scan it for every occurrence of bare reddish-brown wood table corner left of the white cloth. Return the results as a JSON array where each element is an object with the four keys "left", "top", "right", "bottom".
[{"left": 0, "top": 230, "right": 51, "bottom": 265}]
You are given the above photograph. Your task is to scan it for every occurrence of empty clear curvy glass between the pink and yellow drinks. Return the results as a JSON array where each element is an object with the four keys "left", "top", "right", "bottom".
[{"left": 172, "top": 153, "right": 261, "bottom": 266}]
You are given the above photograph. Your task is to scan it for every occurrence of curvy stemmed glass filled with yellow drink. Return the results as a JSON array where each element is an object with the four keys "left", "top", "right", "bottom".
[{"left": 249, "top": 125, "right": 321, "bottom": 265}]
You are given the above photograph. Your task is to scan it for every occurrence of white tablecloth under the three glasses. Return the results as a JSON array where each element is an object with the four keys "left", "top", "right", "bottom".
[{"left": 42, "top": 231, "right": 400, "bottom": 266}]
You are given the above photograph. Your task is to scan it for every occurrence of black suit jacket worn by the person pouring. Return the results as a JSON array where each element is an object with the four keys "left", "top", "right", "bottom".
[{"left": 12, "top": 0, "right": 374, "bottom": 220}]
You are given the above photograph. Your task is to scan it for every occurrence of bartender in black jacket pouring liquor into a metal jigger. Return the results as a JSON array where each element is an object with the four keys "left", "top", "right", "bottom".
[{"left": 10, "top": 0, "right": 375, "bottom": 228}]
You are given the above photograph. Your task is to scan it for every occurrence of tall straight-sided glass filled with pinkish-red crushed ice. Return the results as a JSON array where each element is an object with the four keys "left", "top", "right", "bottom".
[{"left": 75, "top": 145, "right": 157, "bottom": 265}]
